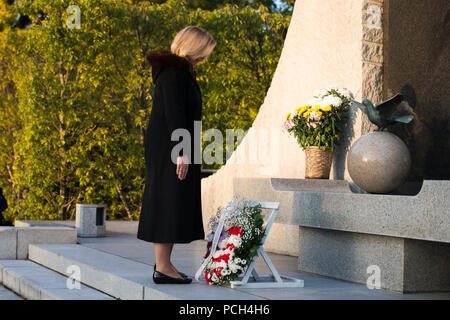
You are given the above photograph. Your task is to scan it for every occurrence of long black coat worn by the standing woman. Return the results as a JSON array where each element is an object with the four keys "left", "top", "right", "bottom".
[{"left": 137, "top": 50, "right": 205, "bottom": 243}]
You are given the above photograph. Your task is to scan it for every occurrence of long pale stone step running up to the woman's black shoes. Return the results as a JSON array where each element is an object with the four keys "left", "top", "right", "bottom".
[{"left": 29, "top": 244, "right": 262, "bottom": 300}]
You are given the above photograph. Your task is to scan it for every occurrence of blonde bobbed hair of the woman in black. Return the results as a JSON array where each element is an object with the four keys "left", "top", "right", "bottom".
[{"left": 170, "top": 26, "right": 216, "bottom": 61}]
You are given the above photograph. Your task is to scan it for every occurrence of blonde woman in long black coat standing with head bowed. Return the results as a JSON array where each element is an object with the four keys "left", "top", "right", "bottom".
[{"left": 137, "top": 26, "right": 216, "bottom": 283}]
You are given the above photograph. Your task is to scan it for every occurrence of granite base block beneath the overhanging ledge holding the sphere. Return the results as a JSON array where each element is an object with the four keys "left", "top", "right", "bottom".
[{"left": 298, "top": 227, "right": 450, "bottom": 293}]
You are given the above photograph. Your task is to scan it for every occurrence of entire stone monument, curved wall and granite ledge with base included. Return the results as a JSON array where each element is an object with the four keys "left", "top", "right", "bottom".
[{"left": 202, "top": 0, "right": 450, "bottom": 292}]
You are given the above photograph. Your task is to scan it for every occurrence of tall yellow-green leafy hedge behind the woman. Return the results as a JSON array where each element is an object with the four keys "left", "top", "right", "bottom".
[{"left": 0, "top": 0, "right": 290, "bottom": 219}]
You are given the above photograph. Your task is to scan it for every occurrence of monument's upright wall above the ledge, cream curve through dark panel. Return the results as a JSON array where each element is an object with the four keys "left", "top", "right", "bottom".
[{"left": 202, "top": 0, "right": 450, "bottom": 255}]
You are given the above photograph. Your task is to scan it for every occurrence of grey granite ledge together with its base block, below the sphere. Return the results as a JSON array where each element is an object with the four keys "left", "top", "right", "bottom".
[{"left": 234, "top": 178, "right": 450, "bottom": 292}]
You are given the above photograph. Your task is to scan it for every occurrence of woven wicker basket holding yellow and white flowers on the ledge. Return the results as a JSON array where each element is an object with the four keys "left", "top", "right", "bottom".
[{"left": 305, "top": 147, "right": 333, "bottom": 179}]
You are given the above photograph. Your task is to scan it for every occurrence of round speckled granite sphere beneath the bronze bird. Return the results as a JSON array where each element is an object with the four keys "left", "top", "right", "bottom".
[{"left": 347, "top": 131, "right": 411, "bottom": 193}]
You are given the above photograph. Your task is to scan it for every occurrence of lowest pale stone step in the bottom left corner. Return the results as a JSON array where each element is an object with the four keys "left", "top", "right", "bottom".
[{"left": 0, "top": 260, "right": 114, "bottom": 300}]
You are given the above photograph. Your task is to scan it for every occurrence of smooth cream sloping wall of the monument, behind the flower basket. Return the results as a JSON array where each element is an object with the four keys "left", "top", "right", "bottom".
[{"left": 202, "top": 0, "right": 368, "bottom": 242}]
